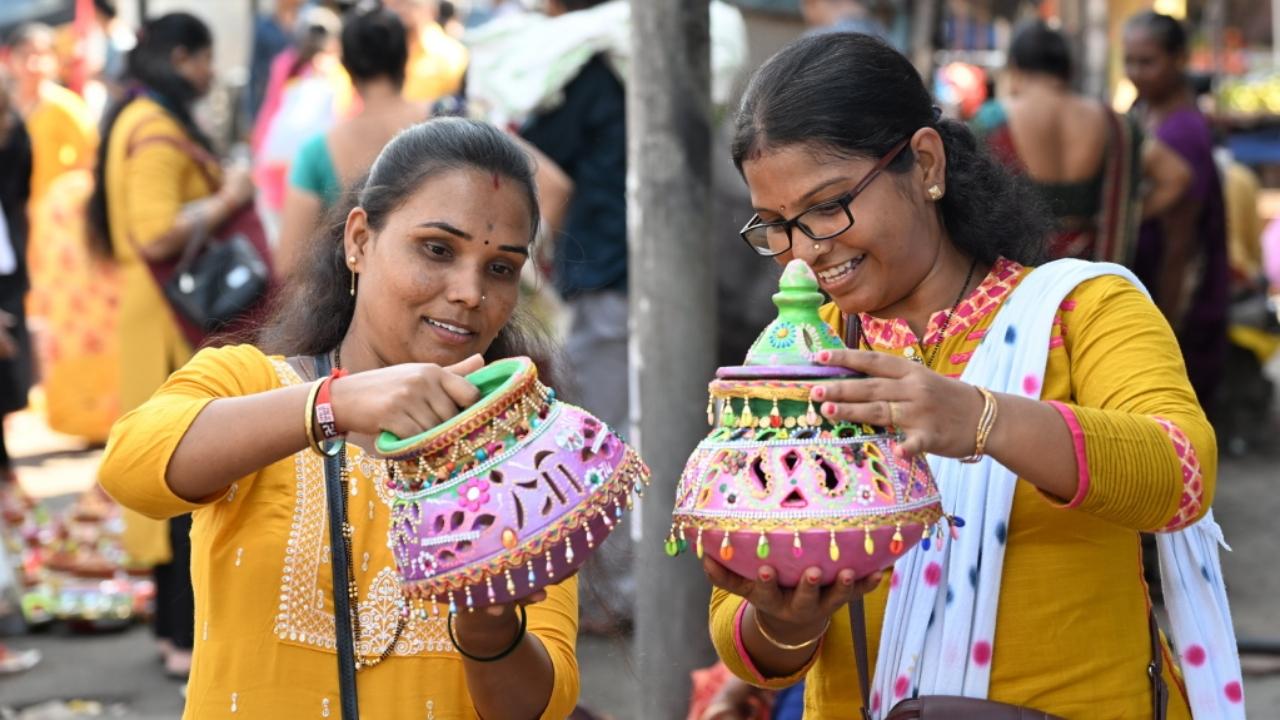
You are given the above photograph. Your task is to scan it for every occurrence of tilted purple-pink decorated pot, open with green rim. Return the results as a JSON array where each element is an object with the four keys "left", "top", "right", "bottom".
[{"left": 376, "top": 357, "right": 649, "bottom": 612}]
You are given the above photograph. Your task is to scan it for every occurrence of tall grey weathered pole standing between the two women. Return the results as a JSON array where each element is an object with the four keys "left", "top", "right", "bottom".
[{"left": 627, "top": 0, "right": 716, "bottom": 719}]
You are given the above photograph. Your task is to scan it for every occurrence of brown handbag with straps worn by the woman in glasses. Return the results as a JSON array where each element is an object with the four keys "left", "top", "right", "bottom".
[{"left": 849, "top": 597, "right": 1169, "bottom": 720}]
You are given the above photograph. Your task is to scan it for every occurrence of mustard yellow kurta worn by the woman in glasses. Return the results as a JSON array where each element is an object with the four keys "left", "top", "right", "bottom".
[{"left": 710, "top": 260, "right": 1217, "bottom": 719}]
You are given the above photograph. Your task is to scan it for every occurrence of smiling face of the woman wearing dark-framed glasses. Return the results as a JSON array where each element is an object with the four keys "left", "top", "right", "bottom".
[{"left": 742, "top": 129, "right": 945, "bottom": 315}]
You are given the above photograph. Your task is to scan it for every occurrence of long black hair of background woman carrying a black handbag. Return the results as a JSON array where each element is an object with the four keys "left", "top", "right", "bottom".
[{"left": 88, "top": 13, "right": 214, "bottom": 258}]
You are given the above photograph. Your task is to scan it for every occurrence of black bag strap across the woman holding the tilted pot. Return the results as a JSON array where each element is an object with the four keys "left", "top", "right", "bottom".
[{"left": 315, "top": 354, "right": 360, "bottom": 720}]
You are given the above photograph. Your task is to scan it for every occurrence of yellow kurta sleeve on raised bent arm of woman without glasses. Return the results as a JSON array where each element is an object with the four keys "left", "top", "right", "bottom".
[{"left": 97, "top": 345, "right": 281, "bottom": 519}]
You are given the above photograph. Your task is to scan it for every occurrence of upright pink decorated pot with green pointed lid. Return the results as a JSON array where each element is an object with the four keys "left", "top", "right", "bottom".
[{"left": 667, "top": 260, "right": 942, "bottom": 587}]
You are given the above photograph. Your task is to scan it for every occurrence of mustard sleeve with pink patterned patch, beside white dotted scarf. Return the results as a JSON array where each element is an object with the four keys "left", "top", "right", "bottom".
[{"left": 1053, "top": 277, "right": 1217, "bottom": 532}]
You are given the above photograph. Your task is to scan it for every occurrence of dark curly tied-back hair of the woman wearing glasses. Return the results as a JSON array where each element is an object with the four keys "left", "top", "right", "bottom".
[{"left": 733, "top": 32, "right": 1051, "bottom": 264}]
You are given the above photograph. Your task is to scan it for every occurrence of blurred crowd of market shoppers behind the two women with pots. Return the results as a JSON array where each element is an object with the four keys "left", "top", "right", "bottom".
[{"left": 0, "top": 0, "right": 1280, "bottom": 717}]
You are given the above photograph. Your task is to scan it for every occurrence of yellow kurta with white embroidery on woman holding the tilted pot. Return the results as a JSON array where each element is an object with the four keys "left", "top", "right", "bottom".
[{"left": 100, "top": 346, "right": 579, "bottom": 720}]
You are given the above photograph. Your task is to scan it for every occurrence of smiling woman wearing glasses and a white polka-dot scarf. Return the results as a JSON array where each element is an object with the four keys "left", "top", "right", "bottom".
[{"left": 704, "top": 33, "right": 1243, "bottom": 717}]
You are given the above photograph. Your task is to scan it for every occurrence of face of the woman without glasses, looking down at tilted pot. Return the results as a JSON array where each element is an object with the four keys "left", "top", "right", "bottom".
[{"left": 344, "top": 169, "right": 532, "bottom": 365}]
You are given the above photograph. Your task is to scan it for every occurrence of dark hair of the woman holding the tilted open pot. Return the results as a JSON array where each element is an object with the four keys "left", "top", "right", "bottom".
[{"left": 257, "top": 118, "right": 562, "bottom": 388}]
